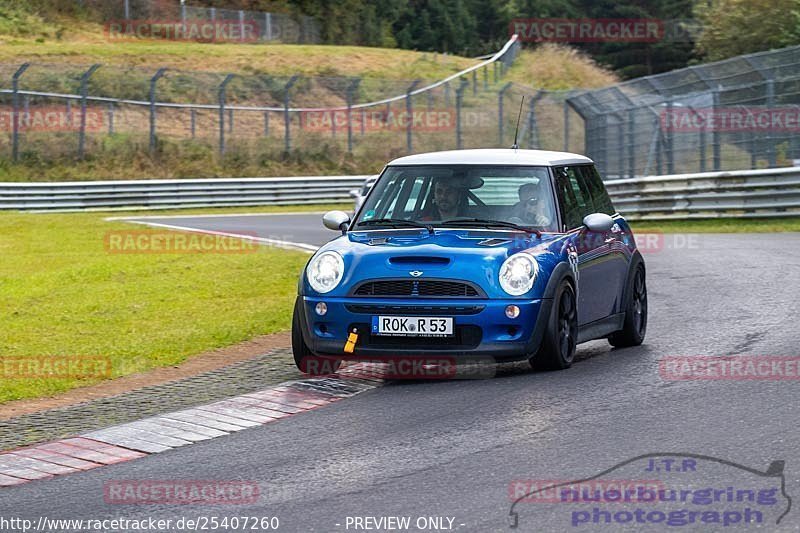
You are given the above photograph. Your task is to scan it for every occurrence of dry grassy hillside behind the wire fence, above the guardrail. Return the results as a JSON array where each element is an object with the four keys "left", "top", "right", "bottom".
[{"left": 0, "top": 3, "right": 616, "bottom": 181}]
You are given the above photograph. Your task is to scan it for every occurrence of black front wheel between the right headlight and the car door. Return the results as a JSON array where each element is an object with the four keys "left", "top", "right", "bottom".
[{"left": 529, "top": 279, "right": 578, "bottom": 370}]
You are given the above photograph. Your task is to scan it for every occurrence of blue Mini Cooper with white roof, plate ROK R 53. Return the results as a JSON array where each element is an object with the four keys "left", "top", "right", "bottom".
[{"left": 292, "top": 149, "right": 647, "bottom": 374}]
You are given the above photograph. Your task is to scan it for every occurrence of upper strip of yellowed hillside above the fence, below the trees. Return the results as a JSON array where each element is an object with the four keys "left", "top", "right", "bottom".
[{"left": 0, "top": 30, "right": 475, "bottom": 80}]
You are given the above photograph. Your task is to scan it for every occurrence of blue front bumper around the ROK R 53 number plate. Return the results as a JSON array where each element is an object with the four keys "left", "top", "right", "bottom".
[{"left": 297, "top": 296, "right": 552, "bottom": 362}]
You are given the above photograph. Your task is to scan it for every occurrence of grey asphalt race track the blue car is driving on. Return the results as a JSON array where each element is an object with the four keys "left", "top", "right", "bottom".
[{"left": 0, "top": 215, "right": 800, "bottom": 532}]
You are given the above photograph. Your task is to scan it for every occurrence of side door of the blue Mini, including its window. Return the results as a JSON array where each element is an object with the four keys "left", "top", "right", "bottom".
[{"left": 554, "top": 165, "right": 619, "bottom": 326}]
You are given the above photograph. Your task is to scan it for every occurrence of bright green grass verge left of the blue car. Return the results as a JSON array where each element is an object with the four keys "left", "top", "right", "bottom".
[{"left": 0, "top": 208, "right": 318, "bottom": 402}]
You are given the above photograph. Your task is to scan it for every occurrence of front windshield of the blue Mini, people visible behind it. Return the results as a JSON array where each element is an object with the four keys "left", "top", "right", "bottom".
[{"left": 352, "top": 165, "right": 556, "bottom": 231}]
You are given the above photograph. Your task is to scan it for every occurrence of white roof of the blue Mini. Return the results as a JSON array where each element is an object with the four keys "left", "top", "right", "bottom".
[{"left": 389, "top": 148, "right": 593, "bottom": 166}]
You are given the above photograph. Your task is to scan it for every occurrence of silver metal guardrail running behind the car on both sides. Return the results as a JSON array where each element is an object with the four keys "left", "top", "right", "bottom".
[{"left": 0, "top": 167, "right": 800, "bottom": 220}]
